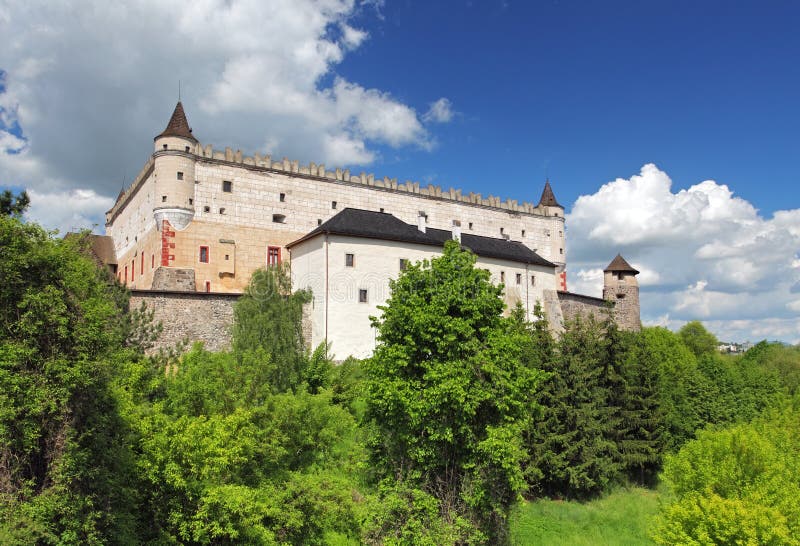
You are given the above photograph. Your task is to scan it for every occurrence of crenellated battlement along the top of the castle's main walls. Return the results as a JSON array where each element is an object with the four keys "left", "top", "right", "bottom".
[{"left": 106, "top": 143, "right": 560, "bottom": 224}]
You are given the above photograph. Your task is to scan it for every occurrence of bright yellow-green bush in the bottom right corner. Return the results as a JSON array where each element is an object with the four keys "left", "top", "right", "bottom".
[{"left": 653, "top": 398, "right": 800, "bottom": 546}]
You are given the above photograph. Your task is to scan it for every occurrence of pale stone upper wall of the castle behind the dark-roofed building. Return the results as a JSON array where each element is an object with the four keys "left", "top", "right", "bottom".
[{"left": 107, "top": 139, "right": 566, "bottom": 292}]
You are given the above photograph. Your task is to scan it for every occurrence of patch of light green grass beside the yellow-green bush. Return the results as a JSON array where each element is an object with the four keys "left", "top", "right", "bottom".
[{"left": 511, "top": 487, "right": 659, "bottom": 546}]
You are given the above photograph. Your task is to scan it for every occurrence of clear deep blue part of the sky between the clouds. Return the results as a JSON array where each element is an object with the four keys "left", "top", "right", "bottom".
[{"left": 339, "top": 1, "right": 800, "bottom": 213}]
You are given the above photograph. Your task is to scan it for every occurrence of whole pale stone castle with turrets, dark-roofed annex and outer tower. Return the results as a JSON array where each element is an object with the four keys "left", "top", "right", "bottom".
[{"left": 102, "top": 102, "right": 639, "bottom": 358}]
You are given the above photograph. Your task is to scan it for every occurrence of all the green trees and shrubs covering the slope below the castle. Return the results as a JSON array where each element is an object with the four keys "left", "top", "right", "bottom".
[{"left": 0, "top": 207, "right": 800, "bottom": 545}]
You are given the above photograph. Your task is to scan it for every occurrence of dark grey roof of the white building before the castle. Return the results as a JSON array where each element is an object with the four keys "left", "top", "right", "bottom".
[{"left": 286, "top": 208, "right": 555, "bottom": 267}]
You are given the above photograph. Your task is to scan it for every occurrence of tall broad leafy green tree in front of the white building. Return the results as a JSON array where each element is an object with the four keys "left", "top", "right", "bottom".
[{"left": 364, "top": 242, "right": 539, "bottom": 543}]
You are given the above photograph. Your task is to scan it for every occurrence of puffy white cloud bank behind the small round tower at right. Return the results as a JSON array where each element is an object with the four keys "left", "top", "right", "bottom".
[{"left": 567, "top": 164, "right": 800, "bottom": 342}]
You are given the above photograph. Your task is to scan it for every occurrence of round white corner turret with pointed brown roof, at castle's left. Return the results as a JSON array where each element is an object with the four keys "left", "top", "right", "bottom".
[{"left": 153, "top": 101, "right": 198, "bottom": 230}]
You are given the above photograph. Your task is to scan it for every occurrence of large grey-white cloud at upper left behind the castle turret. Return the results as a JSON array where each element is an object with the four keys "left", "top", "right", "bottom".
[{"left": 0, "top": 0, "right": 450, "bottom": 230}]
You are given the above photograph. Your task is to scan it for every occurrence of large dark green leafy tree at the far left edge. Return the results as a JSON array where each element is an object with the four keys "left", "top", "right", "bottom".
[{"left": 0, "top": 216, "right": 136, "bottom": 544}]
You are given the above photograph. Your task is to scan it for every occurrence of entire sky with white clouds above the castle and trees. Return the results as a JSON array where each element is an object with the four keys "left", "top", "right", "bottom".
[{"left": 0, "top": 0, "right": 800, "bottom": 342}]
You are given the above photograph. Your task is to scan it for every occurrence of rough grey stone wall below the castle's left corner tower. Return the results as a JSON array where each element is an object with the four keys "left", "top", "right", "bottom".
[{"left": 130, "top": 290, "right": 239, "bottom": 351}]
